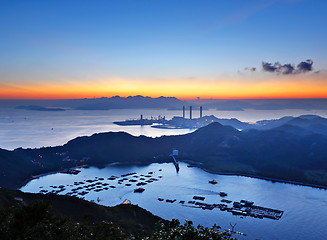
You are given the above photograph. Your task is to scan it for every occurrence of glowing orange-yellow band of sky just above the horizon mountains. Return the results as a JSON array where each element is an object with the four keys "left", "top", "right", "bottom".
[{"left": 0, "top": 76, "right": 327, "bottom": 99}]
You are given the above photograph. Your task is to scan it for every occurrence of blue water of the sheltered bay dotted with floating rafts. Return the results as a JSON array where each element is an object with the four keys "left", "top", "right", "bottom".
[{"left": 21, "top": 163, "right": 327, "bottom": 239}]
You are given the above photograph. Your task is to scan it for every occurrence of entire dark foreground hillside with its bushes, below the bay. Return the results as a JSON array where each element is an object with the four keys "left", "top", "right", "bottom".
[{"left": 0, "top": 188, "right": 235, "bottom": 240}]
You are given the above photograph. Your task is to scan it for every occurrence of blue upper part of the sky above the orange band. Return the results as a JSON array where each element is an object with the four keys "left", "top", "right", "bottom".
[{"left": 0, "top": 0, "right": 327, "bottom": 98}]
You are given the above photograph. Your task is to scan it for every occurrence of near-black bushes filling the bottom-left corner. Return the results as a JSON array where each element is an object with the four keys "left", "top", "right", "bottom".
[{"left": 0, "top": 202, "right": 137, "bottom": 240}]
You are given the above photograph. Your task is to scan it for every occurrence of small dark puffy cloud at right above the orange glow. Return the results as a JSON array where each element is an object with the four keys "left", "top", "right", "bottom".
[{"left": 262, "top": 59, "right": 313, "bottom": 75}]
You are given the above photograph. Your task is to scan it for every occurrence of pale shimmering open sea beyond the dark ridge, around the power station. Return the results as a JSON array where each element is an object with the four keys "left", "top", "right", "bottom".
[{"left": 0, "top": 105, "right": 327, "bottom": 150}]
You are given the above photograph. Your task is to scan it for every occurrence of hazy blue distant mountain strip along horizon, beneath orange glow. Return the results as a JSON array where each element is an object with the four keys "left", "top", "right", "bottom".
[{"left": 0, "top": 95, "right": 327, "bottom": 111}]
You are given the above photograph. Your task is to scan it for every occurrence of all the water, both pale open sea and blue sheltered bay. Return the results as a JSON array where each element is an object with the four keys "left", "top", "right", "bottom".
[{"left": 0, "top": 107, "right": 327, "bottom": 240}]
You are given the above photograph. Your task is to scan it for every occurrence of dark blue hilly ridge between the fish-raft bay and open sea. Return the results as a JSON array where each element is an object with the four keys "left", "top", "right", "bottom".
[{"left": 0, "top": 115, "right": 327, "bottom": 188}]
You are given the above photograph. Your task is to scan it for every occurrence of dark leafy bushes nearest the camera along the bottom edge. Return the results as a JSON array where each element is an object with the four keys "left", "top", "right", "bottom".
[{"left": 0, "top": 201, "right": 236, "bottom": 240}]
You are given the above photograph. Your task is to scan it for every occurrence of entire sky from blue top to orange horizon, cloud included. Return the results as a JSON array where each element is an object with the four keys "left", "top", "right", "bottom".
[{"left": 0, "top": 0, "right": 327, "bottom": 99}]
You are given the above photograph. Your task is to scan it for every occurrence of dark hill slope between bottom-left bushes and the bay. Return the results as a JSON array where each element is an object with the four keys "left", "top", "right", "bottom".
[{"left": 0, "top": 188, "right": 162, "bottom": 236}]
